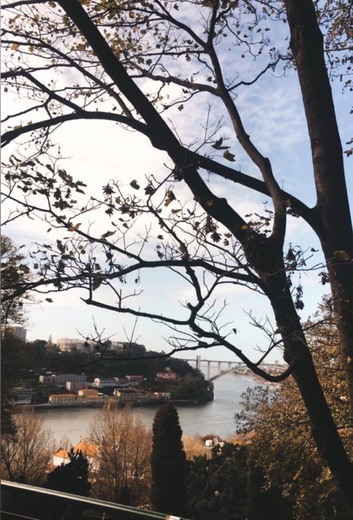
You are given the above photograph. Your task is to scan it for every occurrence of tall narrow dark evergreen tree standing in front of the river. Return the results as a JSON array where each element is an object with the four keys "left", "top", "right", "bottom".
[{"left": 151, "top": 403, "right": 187, "bottom": 516}]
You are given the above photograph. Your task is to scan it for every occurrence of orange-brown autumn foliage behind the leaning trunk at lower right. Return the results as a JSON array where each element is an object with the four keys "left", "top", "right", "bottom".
[{"left": 237, "top": 300, "right": 353, "bottom": 520}]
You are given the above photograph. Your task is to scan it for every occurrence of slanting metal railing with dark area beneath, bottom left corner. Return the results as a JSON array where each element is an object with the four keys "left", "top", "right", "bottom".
[{"left": 1, "top": 480, "right": 187, "bottom": 520}]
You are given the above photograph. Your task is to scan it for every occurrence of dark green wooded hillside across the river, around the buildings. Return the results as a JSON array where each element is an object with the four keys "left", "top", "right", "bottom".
[{"left": 10, "top": 340, "right": 213, "bottom": 403}]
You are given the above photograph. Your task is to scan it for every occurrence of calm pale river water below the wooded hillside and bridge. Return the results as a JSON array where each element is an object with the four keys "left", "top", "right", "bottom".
[{"left": 35, "top": 374, "right": 259, "bottom": 446}]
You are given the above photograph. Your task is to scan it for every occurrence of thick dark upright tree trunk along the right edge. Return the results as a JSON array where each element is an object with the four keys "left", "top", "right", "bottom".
[{"left": 285, "top": 0, "right": 353, "bottom": 417}]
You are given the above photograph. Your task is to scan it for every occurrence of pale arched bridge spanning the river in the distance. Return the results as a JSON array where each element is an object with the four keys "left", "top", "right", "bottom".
[{"left": 183, "top": 356, "right": 284, "bottom": 381}]
